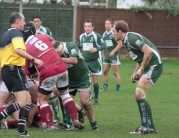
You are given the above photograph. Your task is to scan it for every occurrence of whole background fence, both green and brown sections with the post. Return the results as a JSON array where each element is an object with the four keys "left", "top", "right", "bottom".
[{"left": 0, "top": 3, "right": 179, "bottom": 59}]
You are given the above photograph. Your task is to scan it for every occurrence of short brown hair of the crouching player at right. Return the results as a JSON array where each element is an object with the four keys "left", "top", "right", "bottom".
[{"left": 114, "top": 20, "right": 129, "bottom": 33}]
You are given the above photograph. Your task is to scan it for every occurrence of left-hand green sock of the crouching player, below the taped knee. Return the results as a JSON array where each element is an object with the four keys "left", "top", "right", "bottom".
[{"left": 136, "top": 99, "right": 147, "bottom": 127}]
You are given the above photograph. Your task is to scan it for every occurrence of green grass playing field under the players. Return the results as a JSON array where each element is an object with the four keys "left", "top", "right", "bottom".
[{"left": 0, "top": 59, "right": 179, "bottom": 138}]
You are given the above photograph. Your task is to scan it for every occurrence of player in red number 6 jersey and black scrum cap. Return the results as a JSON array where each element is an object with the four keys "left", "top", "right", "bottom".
[{"left": 23, "top": 23, "right": 84, "bottom": 131}]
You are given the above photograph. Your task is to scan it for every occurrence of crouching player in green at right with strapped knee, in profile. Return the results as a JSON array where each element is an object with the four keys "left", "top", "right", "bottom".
[{"left": 113, "top": 20, "right": 163, "bottom": 134}]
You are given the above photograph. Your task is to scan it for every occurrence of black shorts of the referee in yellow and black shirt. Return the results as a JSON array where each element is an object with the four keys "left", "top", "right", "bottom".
[{"left": 1, "top": 66, "right": 27, "bottom": 92}]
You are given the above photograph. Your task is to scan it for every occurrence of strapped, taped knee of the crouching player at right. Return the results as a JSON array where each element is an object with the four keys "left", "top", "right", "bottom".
[{"left": 135, "top": 82, "right": 149, "bottom": 100}]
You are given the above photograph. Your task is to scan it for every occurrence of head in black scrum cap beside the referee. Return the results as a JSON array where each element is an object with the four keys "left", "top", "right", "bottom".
[{"left": 22, "top": 22, "right": 36, "bottom": 41}]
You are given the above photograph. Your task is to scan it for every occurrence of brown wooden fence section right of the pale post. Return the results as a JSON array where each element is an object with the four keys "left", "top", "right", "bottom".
[{"left": 76, "top": 7, "right": 179, "bottom": 59}]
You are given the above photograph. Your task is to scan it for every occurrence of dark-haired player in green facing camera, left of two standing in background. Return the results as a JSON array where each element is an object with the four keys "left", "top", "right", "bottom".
[{"left": 78, "top": 19, "right": 106, "bottom": 105}]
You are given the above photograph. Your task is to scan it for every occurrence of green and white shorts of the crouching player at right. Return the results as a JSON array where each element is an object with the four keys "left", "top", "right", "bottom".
[{"left": 142, "top": 64, "right": 163, "bottom": 85}]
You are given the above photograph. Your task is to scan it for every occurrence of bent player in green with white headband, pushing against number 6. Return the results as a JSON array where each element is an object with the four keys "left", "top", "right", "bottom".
[{"left": 54, "top": 41, "right": 98, "bottom": 131}]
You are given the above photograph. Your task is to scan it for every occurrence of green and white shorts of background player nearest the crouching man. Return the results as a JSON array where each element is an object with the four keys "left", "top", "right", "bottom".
[{"left": 103, "top": 55, "right": 121, "bottom": 66}]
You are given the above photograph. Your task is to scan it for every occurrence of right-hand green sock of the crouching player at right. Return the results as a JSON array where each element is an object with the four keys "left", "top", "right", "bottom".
[{"left": 145, "top": 101, "right": 155, "bottom": 129}]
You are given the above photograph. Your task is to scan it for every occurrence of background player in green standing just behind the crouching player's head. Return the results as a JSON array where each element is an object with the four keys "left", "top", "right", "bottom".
[{"left": 101, "top": 19, "right": 122, "bottom": 91}]
